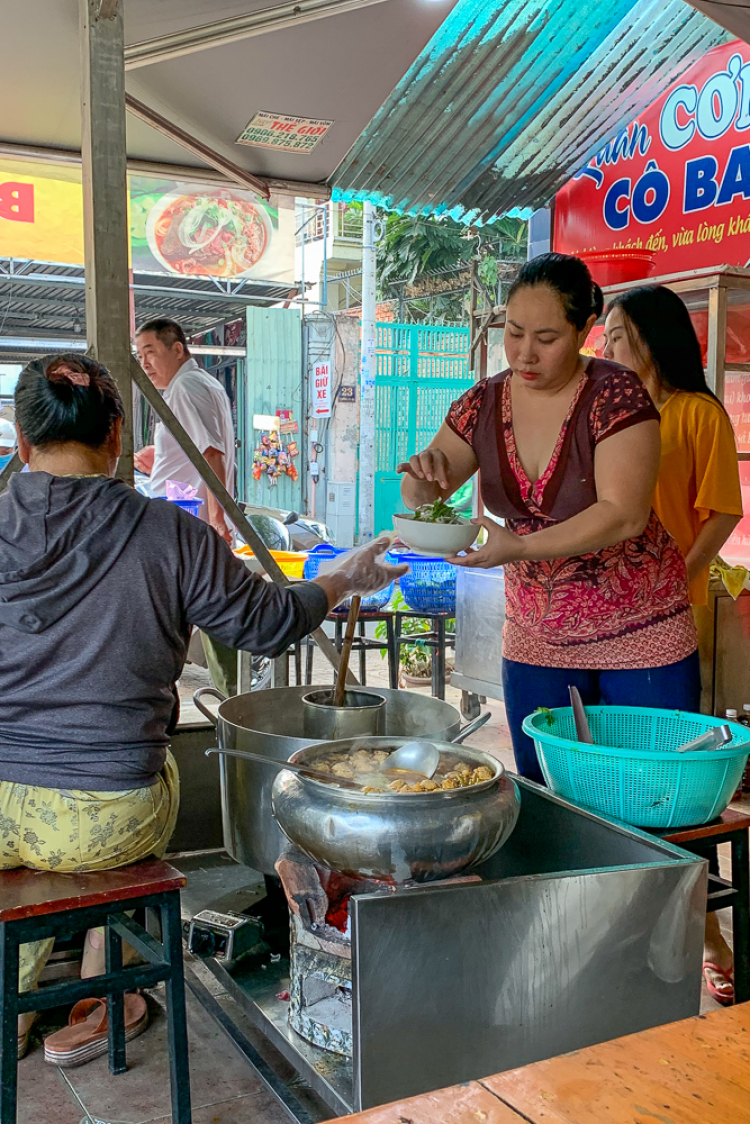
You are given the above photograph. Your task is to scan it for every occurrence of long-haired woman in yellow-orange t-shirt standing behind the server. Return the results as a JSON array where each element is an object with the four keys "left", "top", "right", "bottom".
[{"left": 604, "top": 285, "right": 742, "bottom": 1005}]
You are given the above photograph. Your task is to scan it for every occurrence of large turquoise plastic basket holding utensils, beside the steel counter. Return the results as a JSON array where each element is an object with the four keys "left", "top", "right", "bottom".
[{"left": 523, "top": 706, "right": 750, "bottom": 828}]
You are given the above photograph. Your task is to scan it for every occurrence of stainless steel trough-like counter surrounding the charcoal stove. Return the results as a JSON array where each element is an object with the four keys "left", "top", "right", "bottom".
[{"left": 192, "top": 781, "right": 706, "bottom": 1113}]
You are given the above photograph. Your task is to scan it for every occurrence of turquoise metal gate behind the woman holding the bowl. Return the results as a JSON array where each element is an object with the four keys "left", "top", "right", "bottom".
[{"left": 374, "top": 324, "right": 473, "bottom": 534}]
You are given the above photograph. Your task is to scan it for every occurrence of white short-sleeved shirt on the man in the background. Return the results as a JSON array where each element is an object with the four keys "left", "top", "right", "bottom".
[{"left": 151, "top": 359, "right": 235, "bottom": 522}]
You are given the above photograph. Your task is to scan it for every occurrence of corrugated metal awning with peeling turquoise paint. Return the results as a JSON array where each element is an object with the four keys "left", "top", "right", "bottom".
[{"left": 331, "top": 0, "right": 728, "bottom": 221}]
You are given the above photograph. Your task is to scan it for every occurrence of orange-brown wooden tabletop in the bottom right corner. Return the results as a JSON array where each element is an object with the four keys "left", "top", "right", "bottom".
[{"left": 342, "top": 1004, "right": 750, "bottom": 1124}]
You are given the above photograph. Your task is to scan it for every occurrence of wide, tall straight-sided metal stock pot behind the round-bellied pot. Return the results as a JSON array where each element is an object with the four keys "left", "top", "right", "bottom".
[{"left": 193, "top": 686, "right": 461, "bottom": 874}]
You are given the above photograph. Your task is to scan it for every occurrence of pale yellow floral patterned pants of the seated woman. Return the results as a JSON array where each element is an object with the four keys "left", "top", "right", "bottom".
[{"left": 0, "top": 753, "right": 180, "bottom": 991}]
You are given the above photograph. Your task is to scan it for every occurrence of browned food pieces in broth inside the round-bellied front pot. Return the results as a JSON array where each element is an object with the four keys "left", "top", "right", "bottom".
[{"left": 309, "top": 749, "right": 495, "bottom": 796}]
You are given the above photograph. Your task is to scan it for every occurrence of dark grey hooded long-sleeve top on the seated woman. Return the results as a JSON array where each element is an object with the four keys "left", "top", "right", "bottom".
[{"left": 0, "top": 472, "right": 327, "bottom": 791}]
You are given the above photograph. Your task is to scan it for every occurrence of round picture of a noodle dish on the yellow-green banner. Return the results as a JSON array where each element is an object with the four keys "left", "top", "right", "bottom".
[{"left": 146, "top": 191, "right": 273, "bottom": 278}]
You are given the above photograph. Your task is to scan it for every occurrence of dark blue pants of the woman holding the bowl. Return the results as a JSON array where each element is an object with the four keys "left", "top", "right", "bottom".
[{"left": 503, "top": 652, "right": 701, "bottom": 785}]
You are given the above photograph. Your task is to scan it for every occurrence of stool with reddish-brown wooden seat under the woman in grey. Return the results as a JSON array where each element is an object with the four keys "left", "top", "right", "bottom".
[{"left": 0, "top": 859, "right": 191, "bottom": 1124}]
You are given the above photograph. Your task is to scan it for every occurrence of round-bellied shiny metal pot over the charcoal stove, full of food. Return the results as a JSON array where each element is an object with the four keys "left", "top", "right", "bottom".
[{"left": 273, "top": 737, "right": 521, "bottom": 883}]
